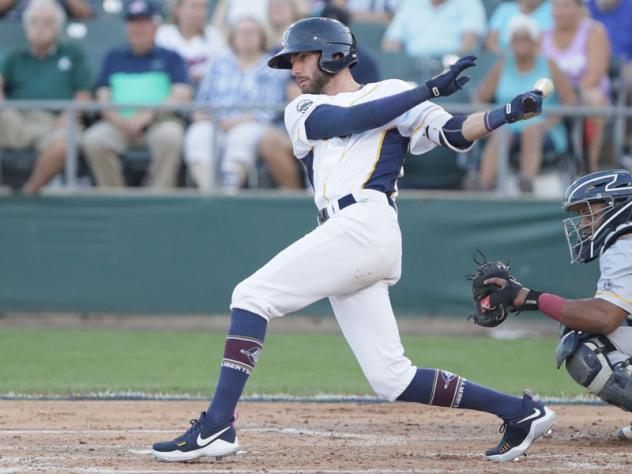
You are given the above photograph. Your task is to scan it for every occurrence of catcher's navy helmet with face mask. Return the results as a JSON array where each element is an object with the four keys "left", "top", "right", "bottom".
[{"left": 562, "top": 170, "right": 632, "bottom": 263}]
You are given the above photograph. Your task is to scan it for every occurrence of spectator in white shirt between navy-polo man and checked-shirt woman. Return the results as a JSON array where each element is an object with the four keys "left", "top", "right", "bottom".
[{"left": 156, "top": 0, "right": 227, "bottom": 86}]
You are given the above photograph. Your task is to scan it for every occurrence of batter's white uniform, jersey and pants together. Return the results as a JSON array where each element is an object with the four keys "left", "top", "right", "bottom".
[{"left": 231, "top": 80, "right": 460, "bottom": 400}]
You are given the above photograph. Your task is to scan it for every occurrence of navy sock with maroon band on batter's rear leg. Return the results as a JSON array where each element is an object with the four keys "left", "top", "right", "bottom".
[{"left": 397, "top": 369, "right": 522, "bottom": 420}]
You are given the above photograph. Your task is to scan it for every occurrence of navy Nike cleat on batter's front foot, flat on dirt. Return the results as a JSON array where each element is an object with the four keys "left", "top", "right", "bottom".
[{"left": 151, "top": 412, "right": 239, "bottom": 461}]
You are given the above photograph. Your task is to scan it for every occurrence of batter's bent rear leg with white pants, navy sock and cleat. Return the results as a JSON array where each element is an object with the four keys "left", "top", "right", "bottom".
[{"left": 330, "top": 281, "right": 555, "bottom": 461}]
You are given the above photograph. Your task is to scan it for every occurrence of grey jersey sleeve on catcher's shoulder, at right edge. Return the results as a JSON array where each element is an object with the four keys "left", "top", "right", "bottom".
[{"left": 595, "top": 244, "right": 632, "bottom": 314}]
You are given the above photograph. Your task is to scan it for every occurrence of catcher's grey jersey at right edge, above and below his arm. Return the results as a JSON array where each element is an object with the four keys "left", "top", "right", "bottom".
[{"left": 595, "top": 224, "right": 632, "bottom": 356}]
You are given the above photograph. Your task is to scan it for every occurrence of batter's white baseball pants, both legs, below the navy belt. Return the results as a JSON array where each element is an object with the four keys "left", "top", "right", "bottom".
[{"left": 231, "top": 190, "right": 416, "bottom": 401}]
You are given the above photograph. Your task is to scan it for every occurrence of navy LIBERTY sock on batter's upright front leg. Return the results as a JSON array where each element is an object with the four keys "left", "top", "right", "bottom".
[{"left": 205, "top": 308, "right": 268, "bottom": 426}]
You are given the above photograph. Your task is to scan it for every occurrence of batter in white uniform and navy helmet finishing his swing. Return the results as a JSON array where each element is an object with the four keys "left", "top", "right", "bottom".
[{"left": 152, "top": 18, "right": 556, "bottom": 461}]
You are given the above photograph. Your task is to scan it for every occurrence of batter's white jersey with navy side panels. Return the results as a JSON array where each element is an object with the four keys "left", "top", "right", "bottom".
[{"left": 285, "top": 79, "right": 452, "bottom": 209}]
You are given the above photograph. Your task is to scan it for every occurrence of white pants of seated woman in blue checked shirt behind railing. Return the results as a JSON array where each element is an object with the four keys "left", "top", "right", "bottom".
[{"left": 184, "top": 120, "right": 268, "bottom": 190}]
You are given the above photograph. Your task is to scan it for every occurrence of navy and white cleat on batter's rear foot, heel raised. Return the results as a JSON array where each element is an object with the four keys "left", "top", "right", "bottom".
[{"left": 485, "top": 390, "right": 557, "bottom": 462}]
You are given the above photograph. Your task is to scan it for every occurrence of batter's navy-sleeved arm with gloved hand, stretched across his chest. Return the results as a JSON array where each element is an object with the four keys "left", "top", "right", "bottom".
[{"left": 305, "top": 56, "right": 476, "bottom": 140}]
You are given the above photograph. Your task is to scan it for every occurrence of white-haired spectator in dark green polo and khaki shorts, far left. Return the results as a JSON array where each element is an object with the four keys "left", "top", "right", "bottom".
[{"left": 0, "top": 0, "right": 91, "bottom": 194}]
